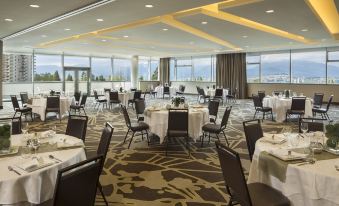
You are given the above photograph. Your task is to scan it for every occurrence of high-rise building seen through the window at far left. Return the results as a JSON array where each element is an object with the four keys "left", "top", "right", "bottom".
[{"left": 2, "top": 54, "right": 32, "bottom": 82}]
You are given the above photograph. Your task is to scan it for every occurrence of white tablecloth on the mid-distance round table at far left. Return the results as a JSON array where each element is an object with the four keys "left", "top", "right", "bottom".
[{"left": 27, "top": 97, "right": 74, "bottom": 121}]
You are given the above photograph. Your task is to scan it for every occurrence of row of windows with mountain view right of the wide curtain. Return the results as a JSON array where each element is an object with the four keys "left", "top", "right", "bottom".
[{"left": 246, "top": 48, "right": 339, "bottom": 84}]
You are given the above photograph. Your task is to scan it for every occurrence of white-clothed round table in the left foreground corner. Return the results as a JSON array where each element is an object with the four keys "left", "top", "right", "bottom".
[{"left": 0, "top": 134, "right": 86, "bottom": 205}]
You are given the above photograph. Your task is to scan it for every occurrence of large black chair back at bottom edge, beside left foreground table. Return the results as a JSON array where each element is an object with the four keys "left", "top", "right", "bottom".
[{"left": 53, "top": 156, "right": 104, "bottom": 206}]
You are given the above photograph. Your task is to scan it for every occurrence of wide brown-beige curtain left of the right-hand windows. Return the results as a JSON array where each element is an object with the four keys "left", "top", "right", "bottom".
[{"left": 216, "top": 53, "right": 247, "bottom": 99}]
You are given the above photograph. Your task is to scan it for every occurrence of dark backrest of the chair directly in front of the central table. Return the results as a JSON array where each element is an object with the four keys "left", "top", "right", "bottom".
[{"left": 168, "top": 109, "right": 188, "bottom": 132}]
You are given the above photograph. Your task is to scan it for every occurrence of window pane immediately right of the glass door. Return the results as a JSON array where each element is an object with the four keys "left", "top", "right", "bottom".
[{"left": 91, "top": 58, "right": 112, "bottom": 82}]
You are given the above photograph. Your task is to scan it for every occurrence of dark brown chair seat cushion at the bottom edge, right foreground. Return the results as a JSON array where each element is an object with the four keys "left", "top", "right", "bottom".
[{"left": 247, "top": 183, "right": 291, "bottom": 206}]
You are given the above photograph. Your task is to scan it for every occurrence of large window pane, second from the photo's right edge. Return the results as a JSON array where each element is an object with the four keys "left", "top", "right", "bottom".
[{"left": 291, "top": 50, "right": 326, "bottom": 84}]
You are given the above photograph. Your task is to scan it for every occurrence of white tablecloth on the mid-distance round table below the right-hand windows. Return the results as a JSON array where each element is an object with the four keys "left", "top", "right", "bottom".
[{"left": 263, "top": 96, "right": 313, "bottom": 122}]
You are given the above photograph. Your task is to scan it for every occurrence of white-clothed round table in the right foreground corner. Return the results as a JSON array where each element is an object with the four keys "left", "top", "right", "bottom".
[{"left": 248, "top": 135, "right": 339, "bottom": 206}]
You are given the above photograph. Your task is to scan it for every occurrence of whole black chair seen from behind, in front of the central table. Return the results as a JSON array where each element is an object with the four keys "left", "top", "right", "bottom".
[{"left": 166, "top": 109, "right": 191, "bottom": 156}]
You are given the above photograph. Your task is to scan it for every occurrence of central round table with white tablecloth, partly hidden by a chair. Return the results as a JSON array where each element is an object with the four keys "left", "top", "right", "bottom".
[{"left": 145, "top": 107, "right": 209, "bottom": 143}]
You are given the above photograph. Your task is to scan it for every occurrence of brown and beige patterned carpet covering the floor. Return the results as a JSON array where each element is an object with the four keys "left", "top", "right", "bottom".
[{"left": 2, "top": 96, "right": 339, "bottom": 206}]
